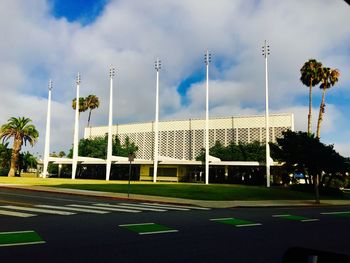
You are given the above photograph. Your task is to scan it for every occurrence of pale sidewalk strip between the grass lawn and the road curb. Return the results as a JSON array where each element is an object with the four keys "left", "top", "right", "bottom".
[{"left": 0, "top": 184, "right": 350, "bottom": 208}]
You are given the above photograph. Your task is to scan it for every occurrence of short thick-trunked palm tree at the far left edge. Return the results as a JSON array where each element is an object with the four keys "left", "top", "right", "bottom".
[{"left": 0, "top": 117, "right": 39, "bottom": 176}]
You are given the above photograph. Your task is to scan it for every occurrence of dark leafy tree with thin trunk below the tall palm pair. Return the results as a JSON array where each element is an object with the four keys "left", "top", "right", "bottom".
[{"left": 270, "top": 131, "right": 349, "bottom": 203}]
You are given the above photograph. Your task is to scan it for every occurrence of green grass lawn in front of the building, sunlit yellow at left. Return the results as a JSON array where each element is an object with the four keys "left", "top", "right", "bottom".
[{"left": 0, "top": 177, "right": 350, "bottom": 200}]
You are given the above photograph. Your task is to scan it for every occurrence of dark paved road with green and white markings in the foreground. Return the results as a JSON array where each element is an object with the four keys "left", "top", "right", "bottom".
[{"left": 0, "top": 189, "right": 350, "bottom": 262}]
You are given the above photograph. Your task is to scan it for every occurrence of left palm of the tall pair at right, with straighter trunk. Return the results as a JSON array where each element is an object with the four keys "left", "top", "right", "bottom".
[{"left": 300, "top": 59, "right": 322, "bottom": 134}]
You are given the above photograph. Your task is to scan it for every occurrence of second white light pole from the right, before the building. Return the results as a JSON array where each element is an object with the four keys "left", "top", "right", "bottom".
[{"left": 204, "top": 50, "right": 211, "bottom": 184}]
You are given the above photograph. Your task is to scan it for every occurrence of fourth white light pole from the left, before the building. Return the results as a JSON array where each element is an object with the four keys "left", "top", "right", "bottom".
[{"left": 153, "top": 58, "right": 161, "bottom": 183}]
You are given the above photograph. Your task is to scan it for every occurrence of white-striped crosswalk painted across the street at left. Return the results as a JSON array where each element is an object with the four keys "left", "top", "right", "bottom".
[{"left": 0, "top": 203, "right": 210, "bottom": 218}]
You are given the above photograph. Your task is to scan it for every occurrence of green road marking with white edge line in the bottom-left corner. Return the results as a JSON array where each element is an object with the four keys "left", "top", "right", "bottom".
[{"left": 0, "top": 230, "right": 45, "bottom": 247}]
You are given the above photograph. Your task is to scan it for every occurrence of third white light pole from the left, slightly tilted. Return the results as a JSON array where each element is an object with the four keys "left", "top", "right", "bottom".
[{"left": 106, "top": 67, "right": 115, "bottom": 181}]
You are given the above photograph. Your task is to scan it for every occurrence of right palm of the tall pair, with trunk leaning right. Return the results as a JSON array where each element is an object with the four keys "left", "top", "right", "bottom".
[{"left": 316, "top": 68, "right": 340, "bottom": 138}]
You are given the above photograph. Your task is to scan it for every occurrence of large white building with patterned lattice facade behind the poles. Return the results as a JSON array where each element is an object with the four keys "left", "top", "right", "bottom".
[{"left": 84, "top": 113, "right": 294, "bottom": 184}]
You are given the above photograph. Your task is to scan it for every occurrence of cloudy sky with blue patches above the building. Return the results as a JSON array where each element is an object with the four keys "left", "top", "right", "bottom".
[{"left": 0, "top": 0, "right": 350, "bottom": 159}]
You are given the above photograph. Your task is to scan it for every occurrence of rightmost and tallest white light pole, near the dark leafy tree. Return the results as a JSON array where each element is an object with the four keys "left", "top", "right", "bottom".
[{"left": 262, "top": 40, "right": 271, "bottom": 187}]
